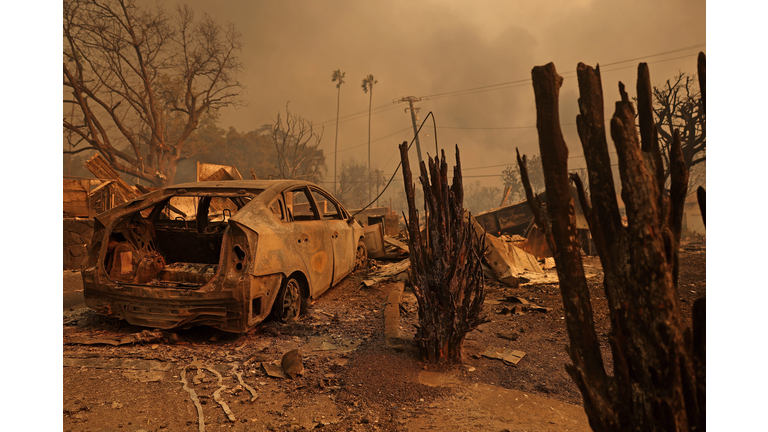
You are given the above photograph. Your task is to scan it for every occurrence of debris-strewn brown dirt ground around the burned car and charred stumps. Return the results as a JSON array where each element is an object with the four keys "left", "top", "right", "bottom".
[{"left": 63, "top": 250, "right": 706, "bottom": 431}]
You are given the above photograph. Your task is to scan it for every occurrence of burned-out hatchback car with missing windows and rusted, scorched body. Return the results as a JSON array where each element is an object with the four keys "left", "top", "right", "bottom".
[{"left": 82, "top": 180, "right": 367, "bottom": 332}]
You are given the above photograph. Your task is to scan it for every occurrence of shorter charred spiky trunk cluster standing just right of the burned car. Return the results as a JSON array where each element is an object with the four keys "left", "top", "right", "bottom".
[{"left": 400, "top": 142, "right": 485, "bottom": 363}]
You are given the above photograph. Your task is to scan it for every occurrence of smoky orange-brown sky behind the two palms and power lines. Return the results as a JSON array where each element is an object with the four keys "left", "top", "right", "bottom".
[{"left": 143, "top": 0, "right": 706, "bottom": 192}]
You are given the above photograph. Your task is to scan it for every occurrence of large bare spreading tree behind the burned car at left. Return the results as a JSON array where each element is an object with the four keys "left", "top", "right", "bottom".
[{"left": 63, "top": 0, "right": 242, "bottom": 186}]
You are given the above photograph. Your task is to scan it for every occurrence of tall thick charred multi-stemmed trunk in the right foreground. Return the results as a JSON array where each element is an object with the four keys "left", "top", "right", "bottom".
[{"left": 518, "top": 55, "right": 705, "bottom": 431}]
